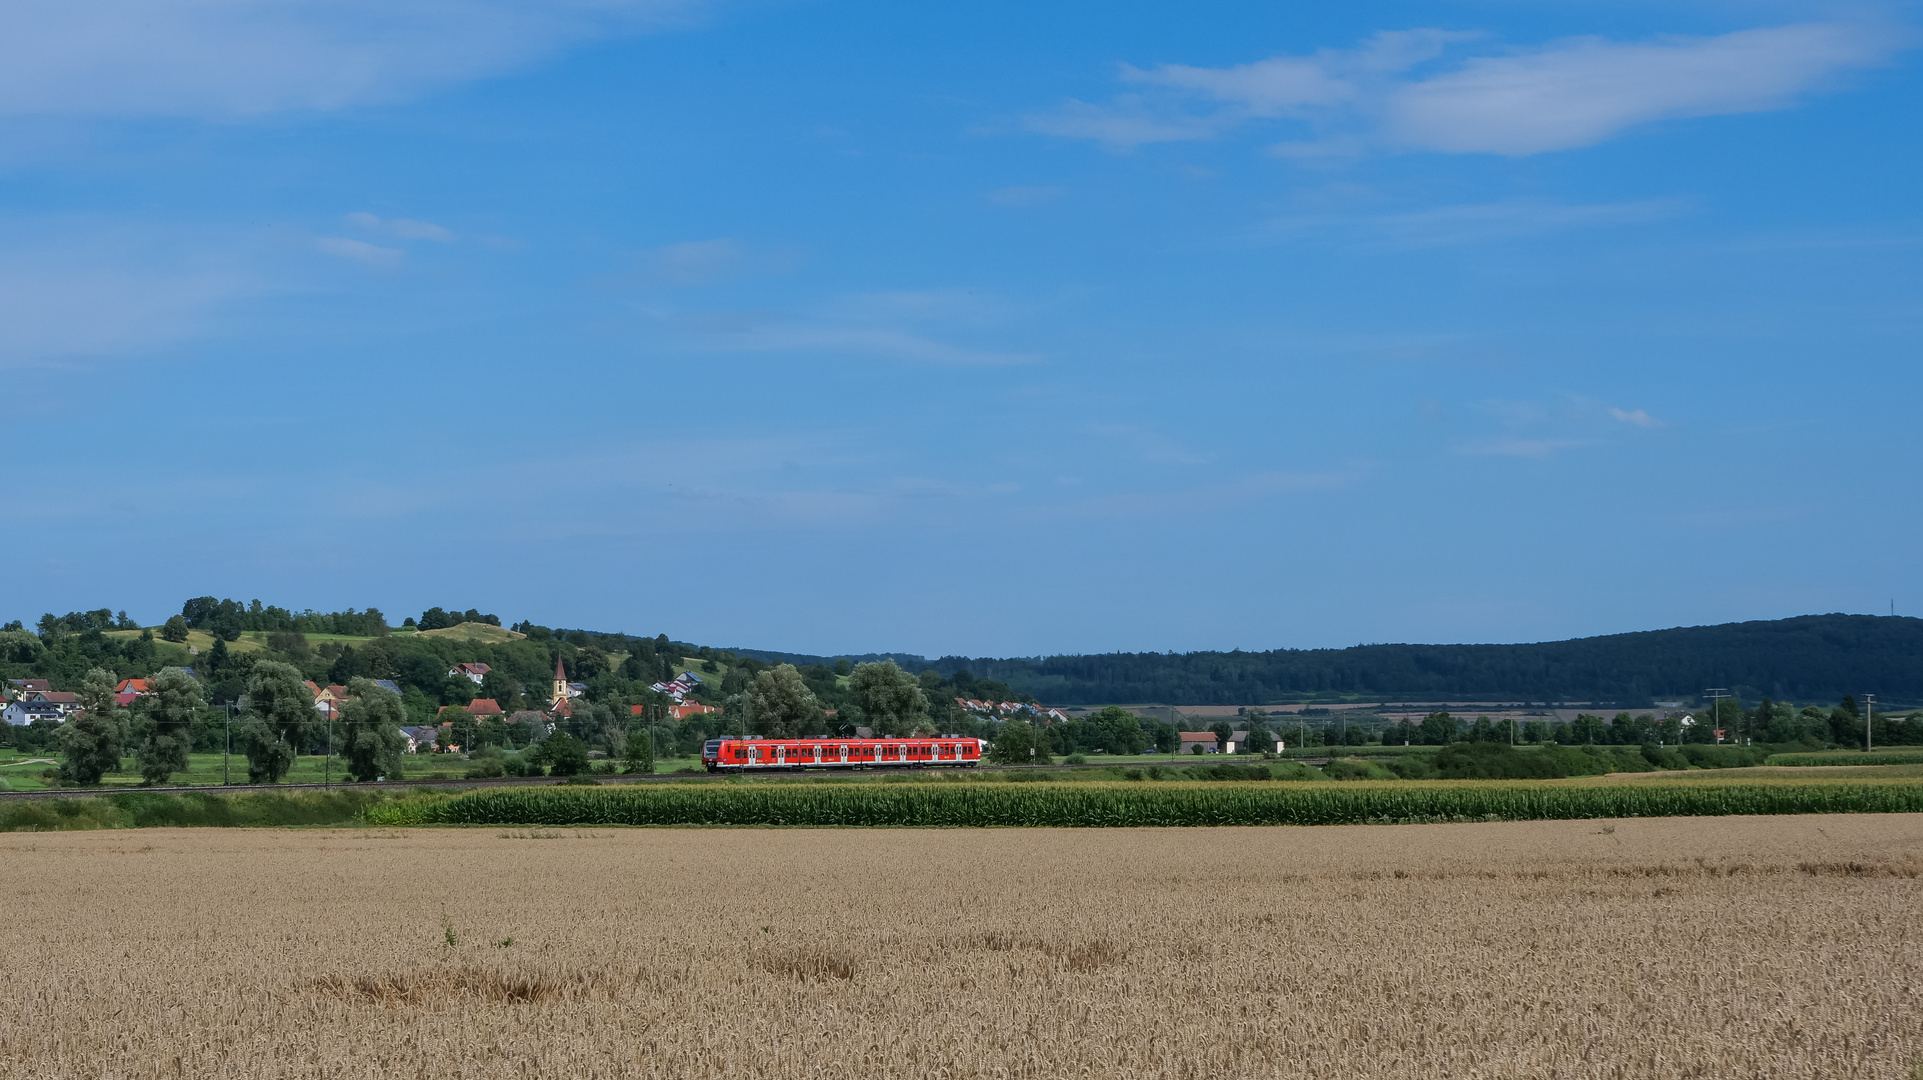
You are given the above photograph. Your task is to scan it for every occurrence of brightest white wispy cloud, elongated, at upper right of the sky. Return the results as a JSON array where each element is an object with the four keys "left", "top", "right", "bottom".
[{"left": 1025, "top": 23, "right": 1906, "bottom": 156}]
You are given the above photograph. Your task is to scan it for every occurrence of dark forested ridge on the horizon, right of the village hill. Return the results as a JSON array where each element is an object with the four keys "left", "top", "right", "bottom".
[{"left": 735, "top": 615, "right": 1923, "bottom": 707}]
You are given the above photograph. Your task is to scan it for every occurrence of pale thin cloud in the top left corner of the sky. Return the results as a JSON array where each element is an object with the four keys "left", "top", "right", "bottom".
[{"left": 0, "top": 0, "right": 696, "bottom": 119}]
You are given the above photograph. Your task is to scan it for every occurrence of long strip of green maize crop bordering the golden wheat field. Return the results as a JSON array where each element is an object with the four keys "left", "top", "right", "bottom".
[{"left": 365, "top": 784, "right": 1923, "bottom": 826}]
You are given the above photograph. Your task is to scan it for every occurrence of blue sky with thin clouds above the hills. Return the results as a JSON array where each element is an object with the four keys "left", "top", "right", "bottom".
[{"left": 0, "top": 0, "right": 1923, "bottom": 655}]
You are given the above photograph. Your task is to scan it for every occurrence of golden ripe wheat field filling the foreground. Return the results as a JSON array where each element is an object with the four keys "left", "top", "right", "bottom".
[{"left": 0, "top": 815, "right": 1923, "bottom": 1080}]
